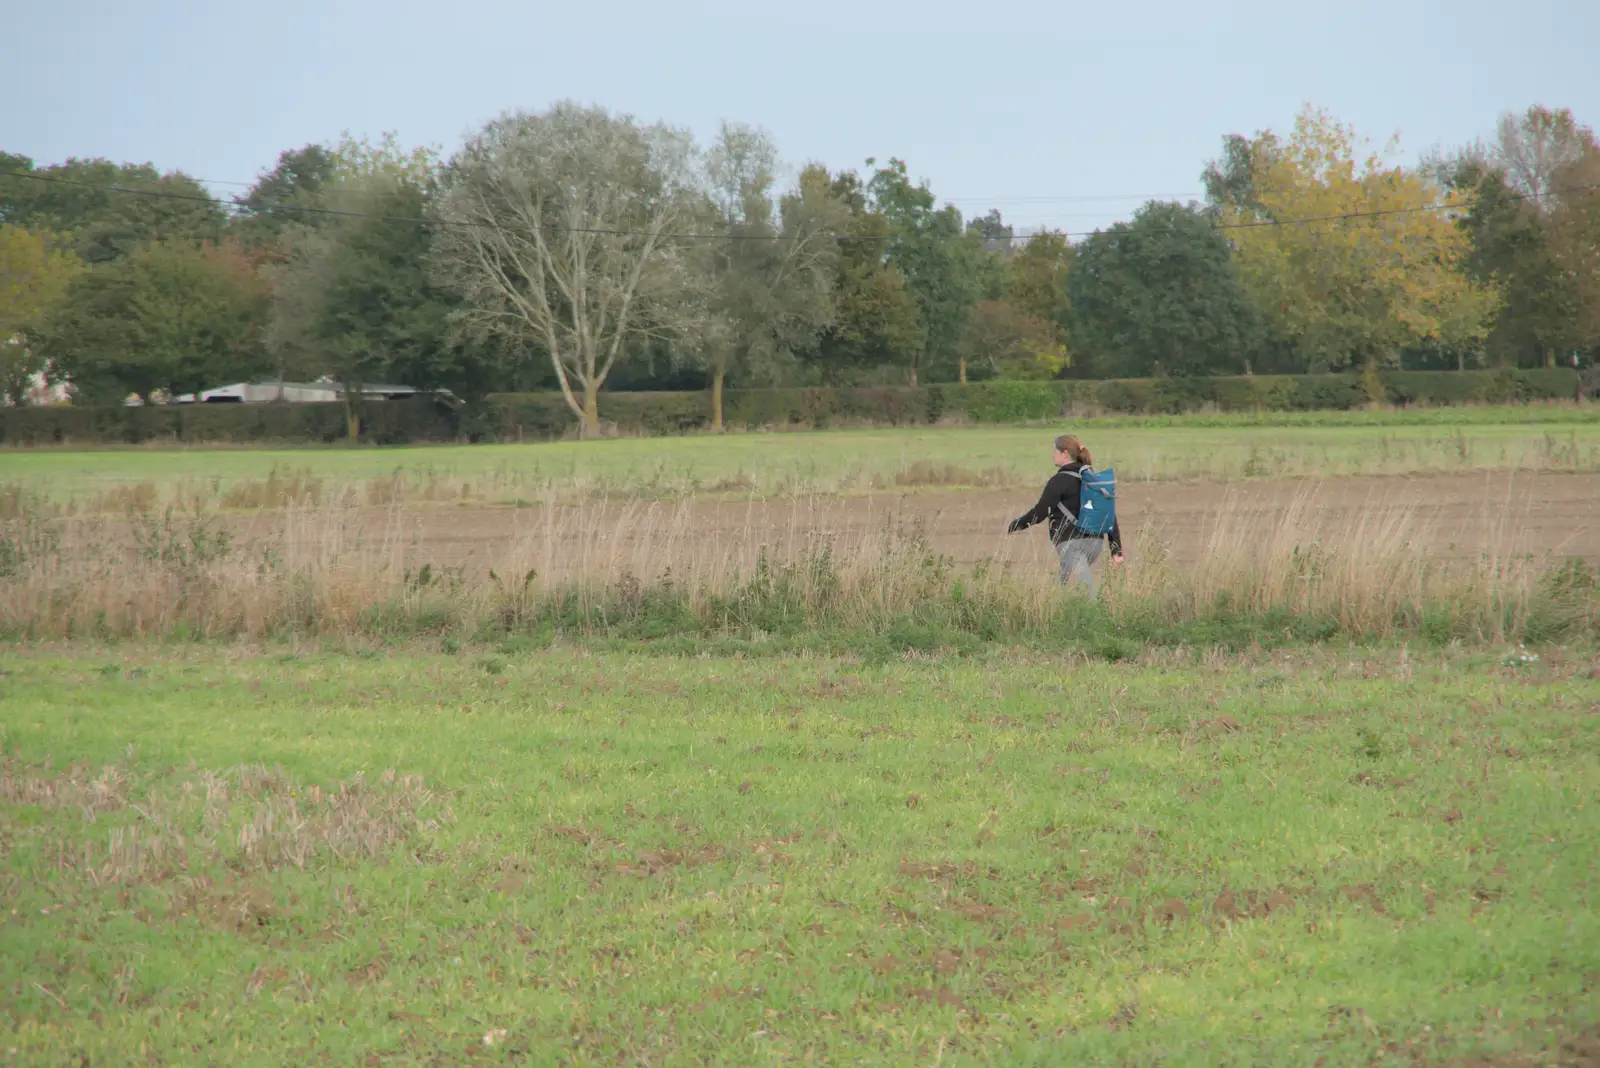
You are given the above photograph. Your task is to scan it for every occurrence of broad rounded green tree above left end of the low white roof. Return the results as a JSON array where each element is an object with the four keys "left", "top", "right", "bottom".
[{"left": 37, "top": 241, "right": 269, "bottom": 403}]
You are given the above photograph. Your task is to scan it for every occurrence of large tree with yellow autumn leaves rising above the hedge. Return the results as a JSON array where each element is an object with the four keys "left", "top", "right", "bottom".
[{"left": 1216, "top": 107, "right": 1498, "bottom": 383}]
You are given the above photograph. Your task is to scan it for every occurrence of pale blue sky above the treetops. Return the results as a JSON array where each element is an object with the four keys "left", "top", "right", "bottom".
[{"left": 0, "top": 0, "right": 1600, "bottom": 230}]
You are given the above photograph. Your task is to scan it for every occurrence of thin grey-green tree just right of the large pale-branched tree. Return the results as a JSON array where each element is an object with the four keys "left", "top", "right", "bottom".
[{"left": 693, "top": 123, "right": 845, "bottom": 430}]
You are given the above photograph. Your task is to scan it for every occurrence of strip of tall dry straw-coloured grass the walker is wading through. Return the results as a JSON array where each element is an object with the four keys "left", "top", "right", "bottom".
[{"left": 0, "top": 486, "right": 1600, "bottom": 641}]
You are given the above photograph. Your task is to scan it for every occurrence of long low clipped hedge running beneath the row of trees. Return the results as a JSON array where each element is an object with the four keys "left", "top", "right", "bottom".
[{"left": 0, "top": 369, "right": 1578, "bottom": 446}]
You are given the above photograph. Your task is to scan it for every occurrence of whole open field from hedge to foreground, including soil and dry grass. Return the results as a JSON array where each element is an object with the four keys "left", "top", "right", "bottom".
[{"left": 9, "top": 409, "right": 1600, "bottom": 1068}]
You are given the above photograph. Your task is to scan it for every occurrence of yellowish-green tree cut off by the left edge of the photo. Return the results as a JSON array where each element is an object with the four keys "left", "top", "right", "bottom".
[{"left": 0, "top": 222, "right": 82, "bottom": 404}]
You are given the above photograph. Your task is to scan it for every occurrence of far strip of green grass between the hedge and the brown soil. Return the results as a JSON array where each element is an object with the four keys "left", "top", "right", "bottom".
[{"left": 0, "top": 408, "right": 1600, "bottom": 502}]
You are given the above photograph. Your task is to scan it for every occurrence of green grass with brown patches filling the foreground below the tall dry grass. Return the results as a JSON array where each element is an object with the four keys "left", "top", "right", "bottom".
[{"left": 0, "top": 646, "right": 1600, "bottom": 1065}]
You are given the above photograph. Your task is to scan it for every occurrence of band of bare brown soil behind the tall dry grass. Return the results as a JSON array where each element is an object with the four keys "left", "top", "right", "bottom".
[{"left": 234, "top": 472, "right": 1600, "bottom": 569}]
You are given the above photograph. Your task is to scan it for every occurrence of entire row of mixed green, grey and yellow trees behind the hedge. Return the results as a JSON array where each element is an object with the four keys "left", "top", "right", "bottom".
[{"left": 0, "top": 102, "right": 1600, "bottom": 433}]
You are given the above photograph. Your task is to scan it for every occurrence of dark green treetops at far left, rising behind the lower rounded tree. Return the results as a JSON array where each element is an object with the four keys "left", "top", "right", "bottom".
[{"left": 0, "top": 155, "right": 227, "bottom": 264}]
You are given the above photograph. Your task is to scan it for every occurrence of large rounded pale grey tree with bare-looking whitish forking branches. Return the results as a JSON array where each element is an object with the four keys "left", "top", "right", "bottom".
[{"left": 434, "top": 102, "right": 701, "bottom": 436}]
